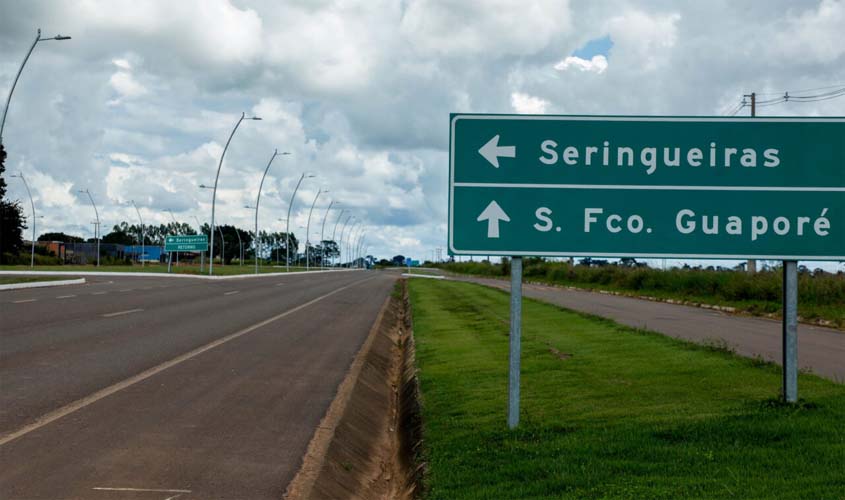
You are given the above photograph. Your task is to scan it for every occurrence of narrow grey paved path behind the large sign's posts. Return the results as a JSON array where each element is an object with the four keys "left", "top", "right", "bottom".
[{"left": 452, "top": 278, "right": 845, "bottom": 380}]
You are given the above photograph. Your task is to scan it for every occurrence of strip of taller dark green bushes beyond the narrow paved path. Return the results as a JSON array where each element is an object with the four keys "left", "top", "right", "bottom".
[{"left": 438, "top": 258, "right": 845, "bottom": 329}]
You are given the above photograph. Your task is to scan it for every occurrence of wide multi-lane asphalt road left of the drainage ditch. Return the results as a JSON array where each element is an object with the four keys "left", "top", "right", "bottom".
[{"left": 0, "top": 272, "right": 396, "bottom": 500}]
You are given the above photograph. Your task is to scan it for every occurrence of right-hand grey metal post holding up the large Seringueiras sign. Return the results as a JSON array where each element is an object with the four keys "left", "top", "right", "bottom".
[{"left": 783, "top": 260, "right": 798, "bottom": 403}]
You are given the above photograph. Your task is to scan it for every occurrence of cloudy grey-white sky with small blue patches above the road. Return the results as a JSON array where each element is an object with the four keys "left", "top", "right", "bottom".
[{"left": 0, "top": 0, "right": 845, "bottom": 264}]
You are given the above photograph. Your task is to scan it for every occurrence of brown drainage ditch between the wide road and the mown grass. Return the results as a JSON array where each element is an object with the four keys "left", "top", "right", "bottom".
[{"left": 285, "top": 280, "right": 422, "bottom": 500}]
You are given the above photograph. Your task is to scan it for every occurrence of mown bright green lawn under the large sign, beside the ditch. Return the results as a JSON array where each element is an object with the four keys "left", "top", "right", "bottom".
[{"left": 409, "top": 280, "right": 845, "bottom": 500}]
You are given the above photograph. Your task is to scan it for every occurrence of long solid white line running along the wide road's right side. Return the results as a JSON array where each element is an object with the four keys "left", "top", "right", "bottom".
[{"left": 0, "top": 276, "right": 377, "bottom": 446}]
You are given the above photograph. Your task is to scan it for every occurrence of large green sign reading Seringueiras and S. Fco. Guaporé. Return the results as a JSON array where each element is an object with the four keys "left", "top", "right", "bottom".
[{"left": 449, "top": 114, "right": 845, "bottom": 260}]
